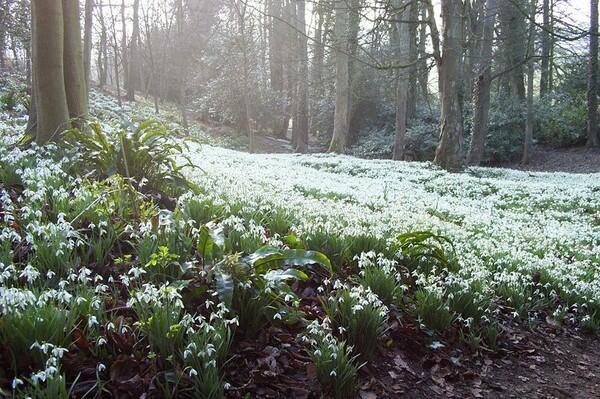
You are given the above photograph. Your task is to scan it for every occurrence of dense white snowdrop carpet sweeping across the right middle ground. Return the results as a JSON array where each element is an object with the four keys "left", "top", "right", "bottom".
[{"left": 183, "top": 145, "right": 600, "bottom": 316}]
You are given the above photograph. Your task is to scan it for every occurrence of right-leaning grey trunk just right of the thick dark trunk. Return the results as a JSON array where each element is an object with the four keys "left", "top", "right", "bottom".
[{"left": 467, "top": 0, "right": 498, "bottom": 165}]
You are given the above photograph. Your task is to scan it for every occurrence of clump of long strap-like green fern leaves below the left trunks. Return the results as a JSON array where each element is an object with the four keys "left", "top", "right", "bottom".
[{"left": 65, "top": 120, "right": 192, "bottom": 192}]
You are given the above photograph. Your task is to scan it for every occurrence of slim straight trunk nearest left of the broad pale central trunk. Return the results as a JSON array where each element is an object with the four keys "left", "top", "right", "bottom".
[{"left": 294, "top": 0, "right": 308, "bottom": 152}]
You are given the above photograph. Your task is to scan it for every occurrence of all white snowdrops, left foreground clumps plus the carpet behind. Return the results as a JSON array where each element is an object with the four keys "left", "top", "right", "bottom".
[{"left": 0, "top": 78, "right": 600, "bottom": 397}]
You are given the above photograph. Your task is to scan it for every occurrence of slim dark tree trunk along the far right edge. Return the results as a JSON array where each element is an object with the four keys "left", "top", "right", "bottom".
[{"left": 587, "top": 0, "right": 600, "bottom": 147}]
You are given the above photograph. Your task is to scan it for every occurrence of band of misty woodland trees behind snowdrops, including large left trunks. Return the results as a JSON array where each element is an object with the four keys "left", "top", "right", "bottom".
[{"left": 0, "top": 0, "right": 600, "bottom": 170}]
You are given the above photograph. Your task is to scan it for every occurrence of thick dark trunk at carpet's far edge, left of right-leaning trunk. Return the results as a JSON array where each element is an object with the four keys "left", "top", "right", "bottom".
[{"left": 434, "top": 0, "right": 463, "bottom": 170}]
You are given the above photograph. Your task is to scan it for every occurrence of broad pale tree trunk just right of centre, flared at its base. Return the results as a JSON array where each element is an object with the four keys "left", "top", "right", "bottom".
[{"left": 329, "top": 0, "right": 350, "bottom": 153}]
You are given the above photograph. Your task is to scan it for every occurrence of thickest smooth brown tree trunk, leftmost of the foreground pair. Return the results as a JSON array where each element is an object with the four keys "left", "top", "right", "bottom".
[{"left": 31, "top": 0, "right": 69, "bottom": 144}]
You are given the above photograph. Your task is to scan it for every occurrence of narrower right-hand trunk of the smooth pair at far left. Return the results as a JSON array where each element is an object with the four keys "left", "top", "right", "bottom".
[{"left": 62, "top": 0, "right": 88, "bottom": 128}]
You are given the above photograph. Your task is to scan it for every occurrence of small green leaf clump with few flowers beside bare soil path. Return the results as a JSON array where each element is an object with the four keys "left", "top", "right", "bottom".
[{"left": 414, "top": 289, "right": 455, "bottom": 332}]
